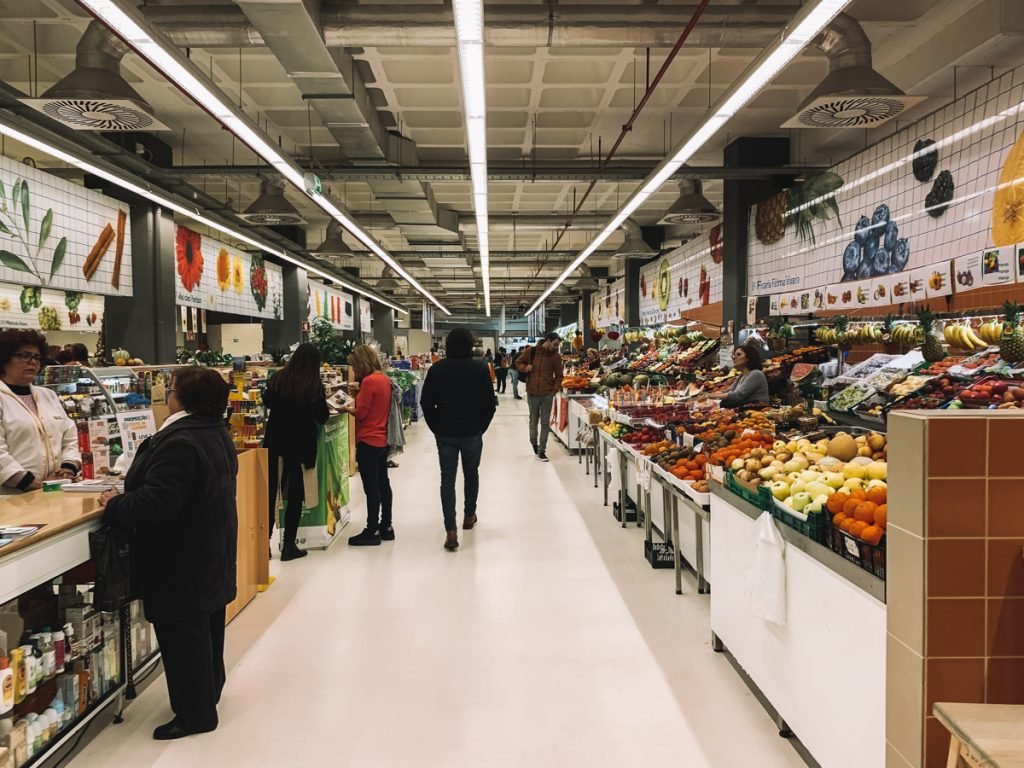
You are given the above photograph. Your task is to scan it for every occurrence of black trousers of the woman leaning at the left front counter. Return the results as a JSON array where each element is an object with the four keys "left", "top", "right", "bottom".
[{"left": 153, "top": 608, "right": 227, "bottom": 731}]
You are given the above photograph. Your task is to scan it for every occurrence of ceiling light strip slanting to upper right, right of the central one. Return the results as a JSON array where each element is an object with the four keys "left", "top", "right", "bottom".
[{"left": 527, "top": 0, "right": 850, "bottom": 312}]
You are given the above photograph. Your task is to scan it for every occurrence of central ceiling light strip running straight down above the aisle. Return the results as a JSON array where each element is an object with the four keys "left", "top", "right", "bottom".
[{"left": 452, "top": 0, "right": 490, "bottom": 317}]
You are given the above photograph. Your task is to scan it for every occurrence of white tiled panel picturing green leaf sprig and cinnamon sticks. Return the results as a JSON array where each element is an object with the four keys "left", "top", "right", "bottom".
[{"left": 0, "top": 157, "right": 132, "bottom": 296}]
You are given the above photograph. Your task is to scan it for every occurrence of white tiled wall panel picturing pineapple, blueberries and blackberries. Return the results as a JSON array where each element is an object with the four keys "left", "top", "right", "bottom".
[{"left": 748, "top": 68, "right": 1024, "bottom": 296}]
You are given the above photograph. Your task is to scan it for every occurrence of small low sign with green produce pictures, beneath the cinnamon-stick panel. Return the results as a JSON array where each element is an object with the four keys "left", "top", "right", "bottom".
[{"left": 0, "top": 285, "right": 103, "bottom": 333}]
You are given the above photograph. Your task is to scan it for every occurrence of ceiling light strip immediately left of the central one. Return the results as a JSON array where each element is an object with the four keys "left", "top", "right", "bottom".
[{"left": 72, "top": 0, "right": 451, "bottom": 314}]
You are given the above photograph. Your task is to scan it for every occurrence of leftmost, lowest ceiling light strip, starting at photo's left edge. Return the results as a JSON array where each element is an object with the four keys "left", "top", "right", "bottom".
[{"left": 0, "top": 119, "right": 409, "bottom": 314}]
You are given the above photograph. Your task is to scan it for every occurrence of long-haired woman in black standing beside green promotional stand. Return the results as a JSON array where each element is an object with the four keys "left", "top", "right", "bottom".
[{"left": 263, "top": 344, "right": 330, "bottom": 560}]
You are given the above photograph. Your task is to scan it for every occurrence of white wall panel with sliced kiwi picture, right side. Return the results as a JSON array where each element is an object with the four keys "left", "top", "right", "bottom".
[{"left": 640, "top": 227, "right": 722, "bottom": 326}]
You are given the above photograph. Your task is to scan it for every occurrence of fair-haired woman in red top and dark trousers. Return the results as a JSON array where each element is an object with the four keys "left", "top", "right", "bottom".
[{"left": 345, "top": 344, "right": 394, "bottom": 547}]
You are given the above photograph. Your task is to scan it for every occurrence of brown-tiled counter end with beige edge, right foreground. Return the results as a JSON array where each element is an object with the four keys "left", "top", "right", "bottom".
[{"left": 886, "top": 411, "right": 1024, "bottom": 768}]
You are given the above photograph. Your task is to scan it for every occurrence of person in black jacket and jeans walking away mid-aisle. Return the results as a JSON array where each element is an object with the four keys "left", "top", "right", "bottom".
[{"left": 420, "top": 328, "right": 497, "bottom": 552}]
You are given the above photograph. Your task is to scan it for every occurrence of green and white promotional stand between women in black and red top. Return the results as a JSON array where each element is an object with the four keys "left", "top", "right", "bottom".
[{"left": 288, "top": 416, "right": 350, "bottom": 549}]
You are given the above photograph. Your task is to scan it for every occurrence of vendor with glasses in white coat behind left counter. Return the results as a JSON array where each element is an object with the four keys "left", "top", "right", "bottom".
[{"left": 0, "top": 329, "right": 82, "bottom": 495}]
